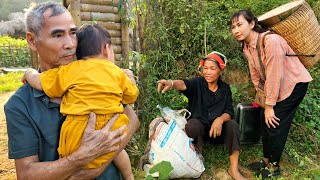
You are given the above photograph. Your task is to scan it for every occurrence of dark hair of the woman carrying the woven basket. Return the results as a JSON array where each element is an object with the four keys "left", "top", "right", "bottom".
[{"left": 230, "top": 10, "right": 268, "bottom": 33}]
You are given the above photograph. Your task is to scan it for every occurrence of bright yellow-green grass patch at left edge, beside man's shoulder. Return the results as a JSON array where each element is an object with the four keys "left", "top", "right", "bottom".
[{"left": 0, "top": 72, "right": 24, "bottom": 93}]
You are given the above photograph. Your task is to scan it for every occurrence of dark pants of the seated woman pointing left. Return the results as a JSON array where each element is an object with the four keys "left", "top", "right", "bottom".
[{"left": 186, "top": 119, "right": 240, "bottom": 156}]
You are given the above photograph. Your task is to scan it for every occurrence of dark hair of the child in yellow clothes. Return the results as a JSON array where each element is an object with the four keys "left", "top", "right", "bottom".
[{"left": 76, "top": 24, "right": 111, "bottom": 59}]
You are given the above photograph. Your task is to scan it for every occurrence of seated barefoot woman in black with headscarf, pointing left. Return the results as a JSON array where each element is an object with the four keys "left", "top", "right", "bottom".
[{"left": 158, "top": 52, "right": 244, "bottom": 180}]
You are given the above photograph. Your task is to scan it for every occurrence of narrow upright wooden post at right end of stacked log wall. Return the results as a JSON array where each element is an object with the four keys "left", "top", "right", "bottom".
[{"left": 121, "top": 1, "right": 129, "bottom": 62}]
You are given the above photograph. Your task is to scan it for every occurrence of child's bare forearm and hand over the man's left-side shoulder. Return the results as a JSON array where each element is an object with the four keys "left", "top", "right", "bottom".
[{"left": 21, "top": 69, "right": 43, "bottom": 91}]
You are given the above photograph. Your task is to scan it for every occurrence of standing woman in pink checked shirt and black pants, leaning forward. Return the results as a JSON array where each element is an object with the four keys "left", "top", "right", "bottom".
[{"left": 231, "top": 10, "right": 312, "bottom": 178}]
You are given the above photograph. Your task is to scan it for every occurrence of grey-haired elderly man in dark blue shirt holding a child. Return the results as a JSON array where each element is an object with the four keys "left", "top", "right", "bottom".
[{"left": 5, "top": 2, "right": 139, "bottom": 180}]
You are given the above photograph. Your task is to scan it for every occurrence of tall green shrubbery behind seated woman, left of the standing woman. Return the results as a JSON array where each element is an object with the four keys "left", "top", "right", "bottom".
[{"left": 139, "top": 0, "right": 289, "bottom": 134}]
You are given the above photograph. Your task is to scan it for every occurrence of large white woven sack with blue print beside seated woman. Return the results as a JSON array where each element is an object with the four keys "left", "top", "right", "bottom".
[{"left": 148, "top": 116, "right": 205, "bottom": 178}]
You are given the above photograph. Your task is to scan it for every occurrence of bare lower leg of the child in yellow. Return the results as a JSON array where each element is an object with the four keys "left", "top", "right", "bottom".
[{"left": 113, "top": 150, "right": 134, "bottom": 180}]
